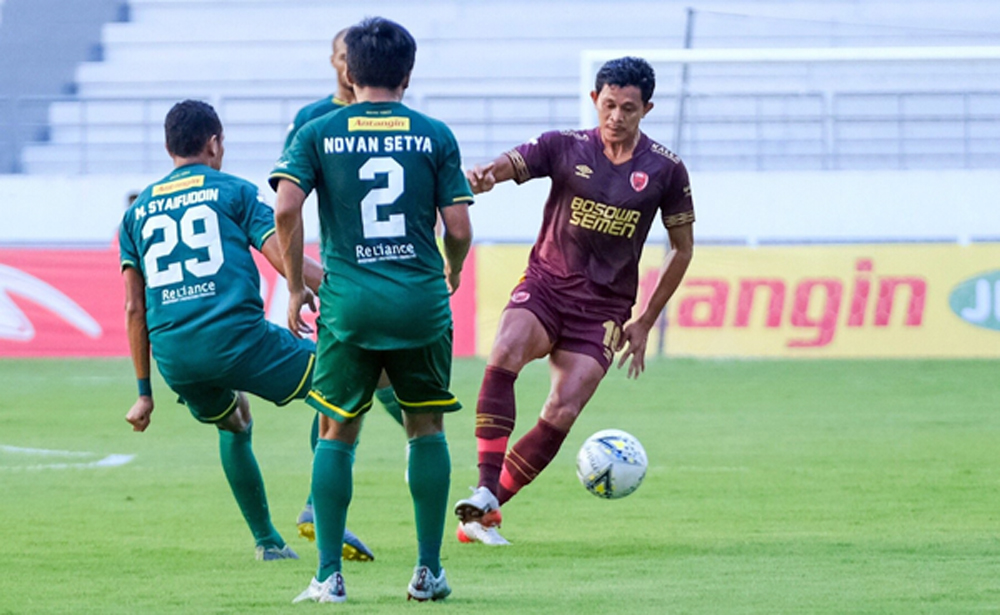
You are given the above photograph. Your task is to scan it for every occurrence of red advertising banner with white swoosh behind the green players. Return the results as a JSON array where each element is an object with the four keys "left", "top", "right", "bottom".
[{"left": 0, "top": 246, "right": 476, "bottom": 357}]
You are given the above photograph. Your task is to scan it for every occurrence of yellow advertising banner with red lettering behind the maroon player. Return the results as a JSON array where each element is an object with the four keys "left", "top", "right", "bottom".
[{"left": 477, "top": 243, "right": 1000, "bottom": 358}]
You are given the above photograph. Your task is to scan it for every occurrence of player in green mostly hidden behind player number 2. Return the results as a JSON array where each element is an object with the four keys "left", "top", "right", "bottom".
[{"left": 283, "top": 28, "right": 403, "bottom": 548}]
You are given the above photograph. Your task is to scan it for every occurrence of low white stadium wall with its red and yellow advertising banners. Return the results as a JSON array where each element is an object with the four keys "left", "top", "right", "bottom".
[{"left": 0, "top": 171, "right": 1000, "bottom": 357}]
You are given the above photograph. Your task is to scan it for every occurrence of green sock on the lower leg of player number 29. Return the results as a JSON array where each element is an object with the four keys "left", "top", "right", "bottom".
[{"left": 219, "top": 424, "right": 285, "bottom": 547}]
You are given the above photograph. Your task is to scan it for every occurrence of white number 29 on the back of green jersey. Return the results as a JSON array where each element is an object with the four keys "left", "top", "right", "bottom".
[{"left": 142, "top": 205, "right": 225, "bottom": 288}]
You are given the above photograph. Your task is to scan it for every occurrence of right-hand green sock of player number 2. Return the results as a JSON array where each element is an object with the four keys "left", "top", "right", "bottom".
[{"left": 408, "top": 433, "right": 451, "bottom": 576}]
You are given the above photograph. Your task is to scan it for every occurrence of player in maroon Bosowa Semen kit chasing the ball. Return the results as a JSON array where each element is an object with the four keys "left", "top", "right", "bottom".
[{"left": 455, "top": 57, "right": 694, "bottom": 545}]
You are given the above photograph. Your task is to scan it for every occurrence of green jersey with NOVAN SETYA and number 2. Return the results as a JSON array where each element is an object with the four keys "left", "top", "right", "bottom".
[{"left": 270, "top": 102, "right": 472, "bottom": 350}]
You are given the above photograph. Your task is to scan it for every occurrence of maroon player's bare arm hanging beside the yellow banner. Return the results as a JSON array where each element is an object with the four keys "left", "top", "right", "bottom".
[{"left": 618, "top": 224, "right": 694, "bottom": 378}]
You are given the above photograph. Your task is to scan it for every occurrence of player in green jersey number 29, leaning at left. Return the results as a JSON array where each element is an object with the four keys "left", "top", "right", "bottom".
[{"left": 118, "top": 100, "right": 370, "bottom": 560}]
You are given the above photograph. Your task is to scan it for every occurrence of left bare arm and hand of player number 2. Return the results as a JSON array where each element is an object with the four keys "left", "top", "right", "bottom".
[{"left": 274, "top": 179, "right": 316, "bottom": 337}]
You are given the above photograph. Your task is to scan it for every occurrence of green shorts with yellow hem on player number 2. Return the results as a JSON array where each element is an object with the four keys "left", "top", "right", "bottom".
[{"left": 306, "top": 320, "right": 462, "bottom": 422}]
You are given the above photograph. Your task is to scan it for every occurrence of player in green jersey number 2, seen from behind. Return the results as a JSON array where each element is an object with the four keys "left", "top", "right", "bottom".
[{"left": 270, "top": 18, "right": 472, "bottom": 602}]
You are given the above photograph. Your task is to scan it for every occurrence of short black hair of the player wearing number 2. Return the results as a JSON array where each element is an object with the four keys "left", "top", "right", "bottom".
[{"left": 344, "top": 17, "right": 417, "bottom": 90}]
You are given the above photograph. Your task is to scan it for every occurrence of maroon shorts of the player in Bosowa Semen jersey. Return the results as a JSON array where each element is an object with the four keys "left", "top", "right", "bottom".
[{"left": 506, "top": 279, "right": 625, "bottom": 372}]
